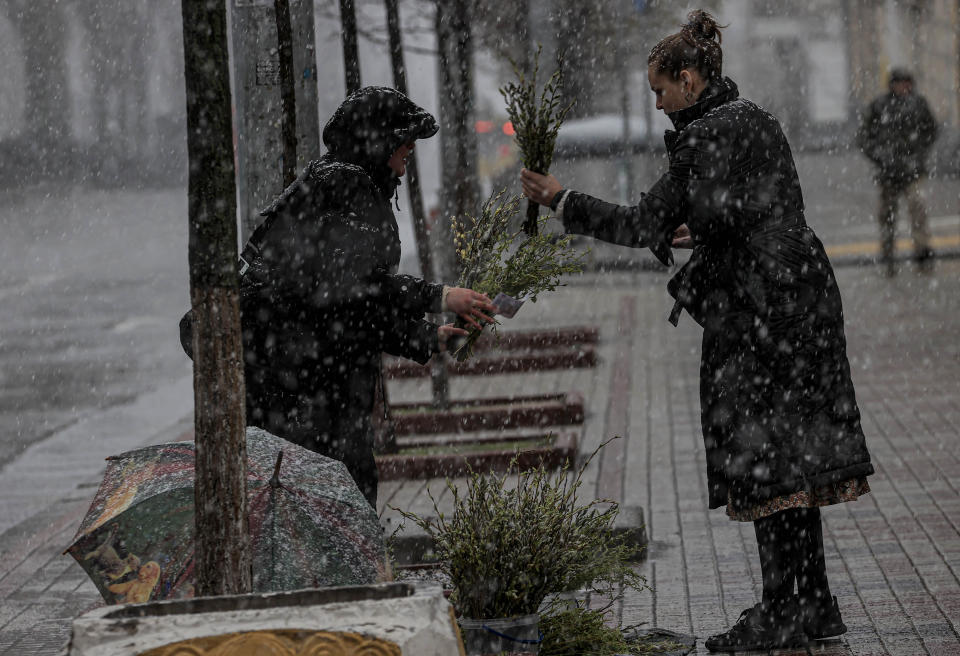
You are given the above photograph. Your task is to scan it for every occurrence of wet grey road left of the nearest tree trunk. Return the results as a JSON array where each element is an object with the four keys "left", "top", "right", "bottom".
[{"left": 0, "top": 187, "right": 190, "bottom": 472}]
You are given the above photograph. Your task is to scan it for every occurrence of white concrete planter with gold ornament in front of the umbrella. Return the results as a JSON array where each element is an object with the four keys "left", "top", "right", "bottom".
[{"left": 67, "top": 583, "right": 464, "bottom": 656}]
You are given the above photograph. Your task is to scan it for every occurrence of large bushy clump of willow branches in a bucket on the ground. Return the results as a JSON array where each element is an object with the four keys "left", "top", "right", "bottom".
[{"left": 397, "top": 445, "right": 646, "bottom": 654}]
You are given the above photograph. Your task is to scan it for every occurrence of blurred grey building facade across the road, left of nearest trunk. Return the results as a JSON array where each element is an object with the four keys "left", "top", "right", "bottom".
[{"left": 0, "top": 0, "right": 186, "bottom": 186}]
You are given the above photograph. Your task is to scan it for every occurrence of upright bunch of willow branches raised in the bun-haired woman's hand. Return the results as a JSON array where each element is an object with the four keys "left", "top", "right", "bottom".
[{"left": 500, "top": 46, "right": 575, "bottom": 235}]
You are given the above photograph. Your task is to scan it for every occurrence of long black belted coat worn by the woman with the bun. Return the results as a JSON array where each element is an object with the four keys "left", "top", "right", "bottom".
[{"left": 562, "top": 78, "right": 873, "bottom": 510}]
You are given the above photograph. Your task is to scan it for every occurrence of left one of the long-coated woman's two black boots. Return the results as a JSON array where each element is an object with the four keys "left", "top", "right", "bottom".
[{"left": 704, "top": 599, "right": 809, "bottom": 652}]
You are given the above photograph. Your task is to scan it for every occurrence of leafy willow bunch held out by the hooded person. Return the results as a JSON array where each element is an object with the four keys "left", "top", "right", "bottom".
[{"left": 452, "top": 190, "right": 587, "bottom": 361}]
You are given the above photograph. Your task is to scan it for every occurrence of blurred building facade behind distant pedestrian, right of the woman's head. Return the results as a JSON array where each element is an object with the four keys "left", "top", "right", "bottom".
[{"left": 720, "top": 0, "right": 960, "bottom": 141}]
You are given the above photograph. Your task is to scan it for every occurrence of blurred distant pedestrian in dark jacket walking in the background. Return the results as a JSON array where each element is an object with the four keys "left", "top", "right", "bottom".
[{"left": 857, "top": 68, "right": 937, "bottom": 275}]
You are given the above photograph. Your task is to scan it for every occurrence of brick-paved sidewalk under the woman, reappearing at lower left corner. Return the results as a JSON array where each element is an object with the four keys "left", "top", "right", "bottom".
[{"left": 0, "top": 260, "right": 960, "bottom": 656}]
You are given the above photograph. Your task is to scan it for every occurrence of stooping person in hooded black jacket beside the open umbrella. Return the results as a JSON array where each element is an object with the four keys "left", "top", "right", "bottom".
[{"left": 241, "top": 87, "right": 495, "bottom": 506}]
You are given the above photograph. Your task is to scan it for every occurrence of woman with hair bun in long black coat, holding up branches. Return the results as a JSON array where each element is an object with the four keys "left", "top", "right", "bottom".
[{"left": 521, "top": 11, "right": 873, "bottom": 651}]
